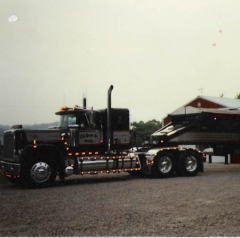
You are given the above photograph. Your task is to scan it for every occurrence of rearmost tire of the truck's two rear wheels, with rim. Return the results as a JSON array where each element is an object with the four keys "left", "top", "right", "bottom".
[{"left": 178, "top": 151, "right": 199, "bottom": 176}]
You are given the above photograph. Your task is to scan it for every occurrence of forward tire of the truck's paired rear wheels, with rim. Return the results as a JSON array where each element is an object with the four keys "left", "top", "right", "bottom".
[{"left": 151, "top": 152, "right": 175, "bottom": 178}]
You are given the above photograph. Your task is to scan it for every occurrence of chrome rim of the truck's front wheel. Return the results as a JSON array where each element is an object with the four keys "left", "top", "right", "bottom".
[{"left": 30, "top": 162, "right": 51, "bottom": 183}]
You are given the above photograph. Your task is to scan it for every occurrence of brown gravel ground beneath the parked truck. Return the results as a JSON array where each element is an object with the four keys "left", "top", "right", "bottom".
[{"left": 0, "top": 163, "right": 240, "bottom": 236}]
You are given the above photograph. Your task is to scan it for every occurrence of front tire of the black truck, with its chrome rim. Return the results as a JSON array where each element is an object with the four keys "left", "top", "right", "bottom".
[{"left": 21, "top": 154, "right": 57, "bottom": 188}]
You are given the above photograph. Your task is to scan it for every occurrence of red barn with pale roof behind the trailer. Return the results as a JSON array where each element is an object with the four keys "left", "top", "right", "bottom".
[{"left": 162, "top": 96, "right": 240, "bottom": 163}]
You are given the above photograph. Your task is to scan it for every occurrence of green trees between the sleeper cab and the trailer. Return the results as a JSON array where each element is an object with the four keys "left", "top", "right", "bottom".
[{"left": 131, "top": 119, "right": 162, "bottom": 146}]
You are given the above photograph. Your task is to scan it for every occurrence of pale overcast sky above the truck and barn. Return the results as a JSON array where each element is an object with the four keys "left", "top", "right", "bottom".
[{"left": 0, "top": 0, "right": 240, "bottom": 125}]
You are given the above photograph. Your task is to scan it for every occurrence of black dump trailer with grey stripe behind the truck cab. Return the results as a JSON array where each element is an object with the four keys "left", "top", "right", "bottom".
[{"left": 150, "top": 109, "right": 240, "bottom": 155}]
